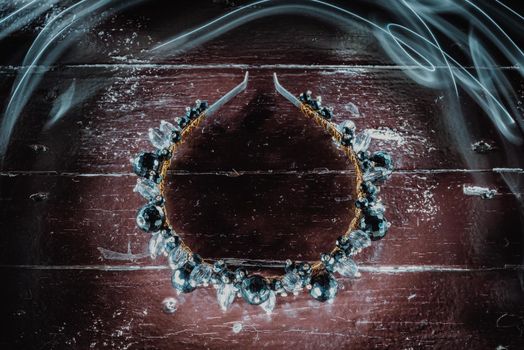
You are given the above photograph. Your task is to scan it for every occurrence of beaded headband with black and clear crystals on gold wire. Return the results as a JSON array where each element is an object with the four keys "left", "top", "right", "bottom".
[{"left": 131, "top": 73, "right": 393, "bottom": 313}]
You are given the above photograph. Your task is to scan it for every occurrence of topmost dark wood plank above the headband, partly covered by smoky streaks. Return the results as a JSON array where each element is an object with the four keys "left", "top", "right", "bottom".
[{"left": 0, "top": 1, "right": 391, "bottom": 65}]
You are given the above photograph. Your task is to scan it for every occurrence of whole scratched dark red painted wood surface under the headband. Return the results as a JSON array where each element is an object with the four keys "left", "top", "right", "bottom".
[{"left": 0, "top": 2, "right": 524, "bottom": 349}]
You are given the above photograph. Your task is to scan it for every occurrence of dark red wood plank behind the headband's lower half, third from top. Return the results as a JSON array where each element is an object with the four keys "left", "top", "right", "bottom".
[{"left": 0, "top": 173, "right": 522, "bottom": 267}]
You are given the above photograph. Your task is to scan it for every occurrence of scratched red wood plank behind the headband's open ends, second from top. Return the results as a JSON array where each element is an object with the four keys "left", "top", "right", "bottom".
[{"left": 0, "top": 69, "right": 510, "bottom": 173}]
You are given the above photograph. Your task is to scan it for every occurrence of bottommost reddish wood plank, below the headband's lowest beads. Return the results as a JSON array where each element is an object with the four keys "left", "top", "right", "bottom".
[{"left": 0, "top": 268, "right": 524, "bottom": 349}]
